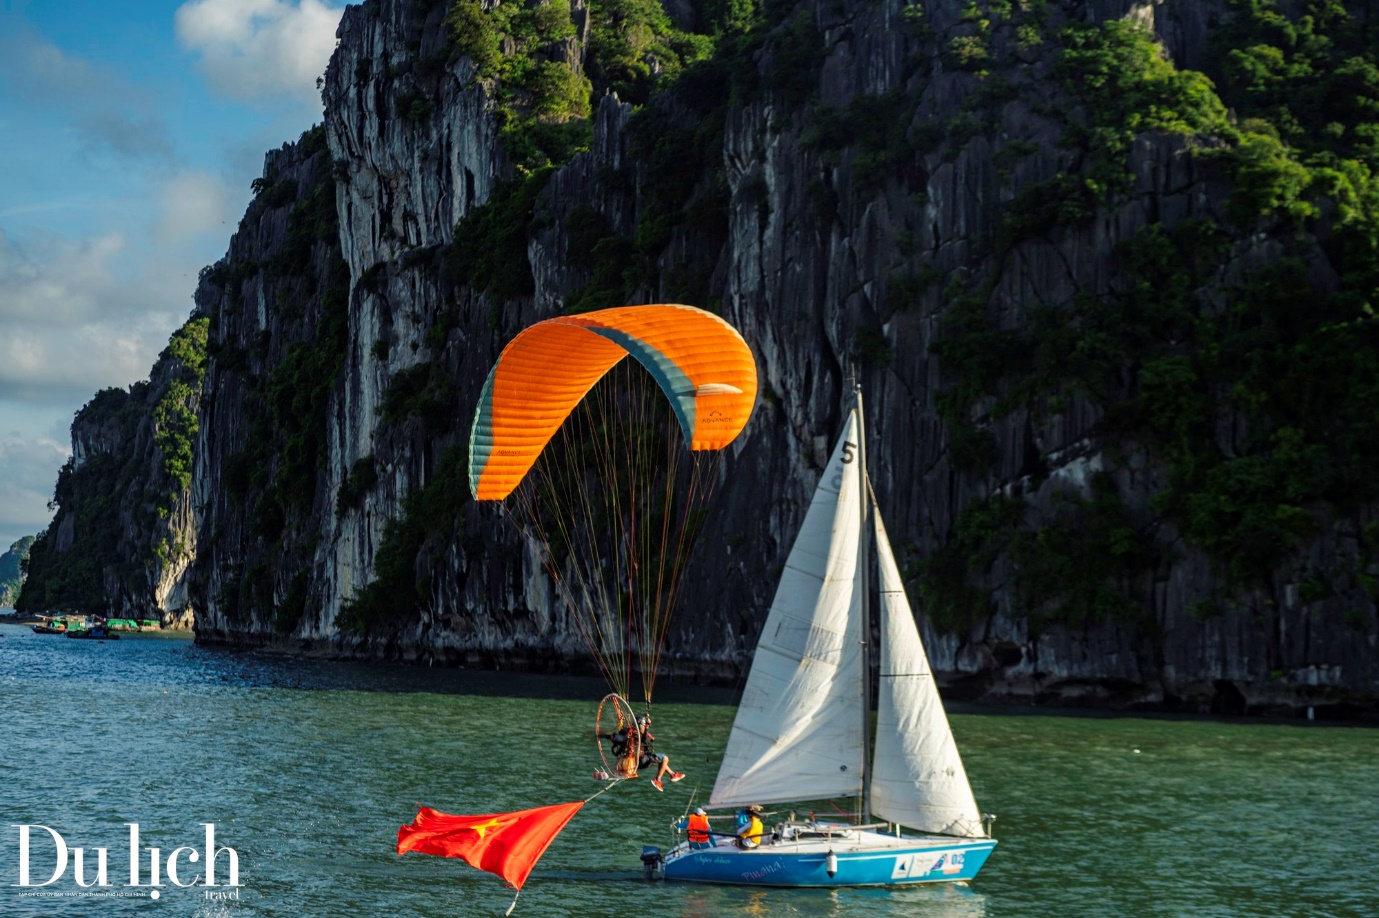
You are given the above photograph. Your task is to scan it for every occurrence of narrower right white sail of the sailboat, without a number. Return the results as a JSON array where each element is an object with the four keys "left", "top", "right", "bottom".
[{"left": 870, "top": 507, "right": 986, "bottom": 838}]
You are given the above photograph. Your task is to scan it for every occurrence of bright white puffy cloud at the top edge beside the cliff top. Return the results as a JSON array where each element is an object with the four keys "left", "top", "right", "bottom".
[{"left": 175, "top": 0, "right": 343, "bottom": 106}]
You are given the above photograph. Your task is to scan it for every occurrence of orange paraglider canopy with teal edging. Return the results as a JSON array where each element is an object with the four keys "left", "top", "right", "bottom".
[{"left": 469, "top": 305, "right": 757, "bottom": 500}]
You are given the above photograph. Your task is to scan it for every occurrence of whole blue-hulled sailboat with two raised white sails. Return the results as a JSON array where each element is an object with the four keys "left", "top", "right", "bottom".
[{"left": 661, "top": 390, "right": 996, "bottom": 888}]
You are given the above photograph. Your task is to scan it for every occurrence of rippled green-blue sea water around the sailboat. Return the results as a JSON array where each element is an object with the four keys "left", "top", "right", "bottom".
[{"left": 0, "top": 624, "right": 1379, "bottom": 918}]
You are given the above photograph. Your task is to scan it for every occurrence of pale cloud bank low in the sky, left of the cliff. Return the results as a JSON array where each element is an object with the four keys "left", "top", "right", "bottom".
[{"left": 0, "top": 187, "right": 206, "bottom": 546}]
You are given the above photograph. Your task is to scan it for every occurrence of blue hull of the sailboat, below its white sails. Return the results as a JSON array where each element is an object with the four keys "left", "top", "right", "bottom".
[{"left": 663, "top": 833, "right": 996, "bottom": 886}]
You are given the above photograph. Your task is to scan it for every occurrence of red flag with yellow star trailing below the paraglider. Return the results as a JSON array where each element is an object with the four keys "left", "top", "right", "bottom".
[{"left": 397, "top": 801, "right": 585, "bottom": 889}]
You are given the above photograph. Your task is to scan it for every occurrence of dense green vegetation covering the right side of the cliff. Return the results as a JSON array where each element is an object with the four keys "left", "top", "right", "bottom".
[{"left": 924, "top": 0, "right": 1379, "bottom": 627}]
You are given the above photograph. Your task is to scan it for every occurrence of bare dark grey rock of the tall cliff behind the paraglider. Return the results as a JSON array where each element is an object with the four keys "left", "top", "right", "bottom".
[{"left": 26, "top": 0, "right": 1379, "bottom": 713}]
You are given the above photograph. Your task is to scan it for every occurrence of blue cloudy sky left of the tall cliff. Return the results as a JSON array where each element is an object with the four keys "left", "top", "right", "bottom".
[{"left": 0, "top": 0, "right": 343, "bottom": 553}]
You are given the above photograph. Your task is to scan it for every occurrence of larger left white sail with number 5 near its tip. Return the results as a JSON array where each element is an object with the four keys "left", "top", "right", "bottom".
[{"left": 709, "top": 411, "right": 865, "bottom": 806}]
